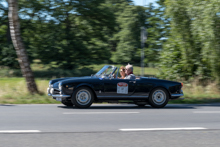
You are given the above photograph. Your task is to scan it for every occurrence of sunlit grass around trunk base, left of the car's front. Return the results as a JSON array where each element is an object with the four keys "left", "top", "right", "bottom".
[{"left": 0, "top": 78, "right": 58, "bottom": 104}]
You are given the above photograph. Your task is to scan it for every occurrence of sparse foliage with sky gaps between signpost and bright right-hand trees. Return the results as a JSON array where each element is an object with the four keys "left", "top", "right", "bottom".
[{"left": 145, "top": 0, "right": 170, "bottom": 65}]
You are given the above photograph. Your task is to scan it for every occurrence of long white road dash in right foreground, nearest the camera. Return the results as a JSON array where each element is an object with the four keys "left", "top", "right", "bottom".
[{"left": 119, "top": 127, "right": 207, "bottom": 131}]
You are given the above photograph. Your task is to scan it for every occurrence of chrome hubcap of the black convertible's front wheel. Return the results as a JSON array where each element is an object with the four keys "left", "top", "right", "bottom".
[{"left": 76, "top": 89, "right": 91, "bottom": 105}]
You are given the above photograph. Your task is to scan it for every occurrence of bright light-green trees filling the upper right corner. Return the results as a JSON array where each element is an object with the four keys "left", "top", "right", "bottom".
[{"left": 161, "top": 0, "right": 220, "bottom": 79}]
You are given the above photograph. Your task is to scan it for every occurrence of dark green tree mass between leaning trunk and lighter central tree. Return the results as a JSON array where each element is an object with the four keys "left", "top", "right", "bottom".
[{"left": 17, "top": 0, "right": 114, "bottom": 69}]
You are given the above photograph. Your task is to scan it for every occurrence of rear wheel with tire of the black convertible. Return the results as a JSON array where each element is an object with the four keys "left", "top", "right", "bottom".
[{"left": 148, "top": 88, "right": 169, "bottom": 108}]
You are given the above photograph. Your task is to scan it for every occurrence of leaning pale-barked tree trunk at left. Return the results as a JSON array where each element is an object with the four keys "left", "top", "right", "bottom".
[{"left": 8, "top": 0, "right": 38, "bottom": 94}]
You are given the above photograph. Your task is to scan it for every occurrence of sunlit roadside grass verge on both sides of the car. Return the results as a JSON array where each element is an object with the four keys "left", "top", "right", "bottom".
[{"left": 0, "top": 78, "right": 220, "bottom": 104}]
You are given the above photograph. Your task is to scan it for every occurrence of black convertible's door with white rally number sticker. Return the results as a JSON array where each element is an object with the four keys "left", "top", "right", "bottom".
[{"left": 103, "top": 79, "right": 136, "bottom": 97}]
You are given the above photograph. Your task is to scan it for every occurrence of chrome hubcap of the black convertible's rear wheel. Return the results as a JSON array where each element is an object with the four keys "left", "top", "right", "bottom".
[{"left": 152, "top": 90, "right": 166, "bottom": 105}]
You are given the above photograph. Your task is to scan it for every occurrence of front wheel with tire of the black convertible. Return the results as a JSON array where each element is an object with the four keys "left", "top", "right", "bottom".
[{"left": 71, "top": 87, "right": 94, "bottom": 108}]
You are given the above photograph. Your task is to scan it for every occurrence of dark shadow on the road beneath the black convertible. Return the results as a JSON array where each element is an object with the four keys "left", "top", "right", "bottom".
[{"left": 57, "top": 104, "right": 196, "bottom": 109}]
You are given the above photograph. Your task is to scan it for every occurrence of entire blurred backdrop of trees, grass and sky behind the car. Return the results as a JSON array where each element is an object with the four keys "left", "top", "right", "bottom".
[{"left": 0, "top": 0, "right": 220, "bottom": 103}]
